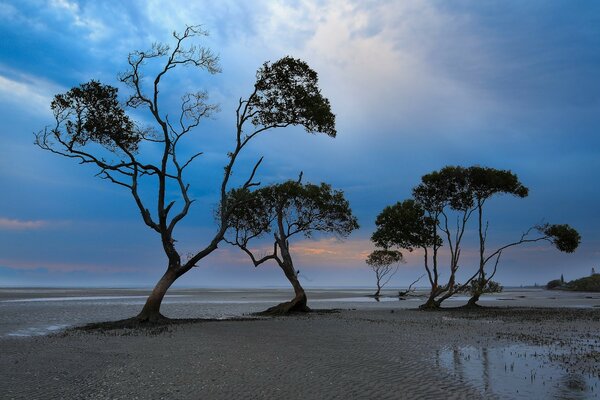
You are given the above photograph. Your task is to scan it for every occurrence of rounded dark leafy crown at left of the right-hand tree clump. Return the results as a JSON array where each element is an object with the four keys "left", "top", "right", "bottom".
[{"left": 371, "top": 199, "right": 441, "bottom": 251}]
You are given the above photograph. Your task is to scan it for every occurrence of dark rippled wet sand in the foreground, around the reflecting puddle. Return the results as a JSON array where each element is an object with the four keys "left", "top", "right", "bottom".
[{"left": 0, "top": 306, "right": 600, "bottom": 399}]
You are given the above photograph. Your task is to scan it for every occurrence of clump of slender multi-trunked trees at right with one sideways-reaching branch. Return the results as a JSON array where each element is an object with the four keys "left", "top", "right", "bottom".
[{"left": 372, "top": 166, "right": 580, "bottom": 309}]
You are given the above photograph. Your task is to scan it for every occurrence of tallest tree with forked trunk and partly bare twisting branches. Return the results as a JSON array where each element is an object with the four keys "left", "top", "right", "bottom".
[{"left": 35, "top": 26, "right": 336, "bottom": 321}]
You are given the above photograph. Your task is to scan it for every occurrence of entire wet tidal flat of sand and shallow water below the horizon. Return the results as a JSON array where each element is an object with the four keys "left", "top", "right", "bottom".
[{"left": 0, "top": 289, "right": 600, "bottom": 399}]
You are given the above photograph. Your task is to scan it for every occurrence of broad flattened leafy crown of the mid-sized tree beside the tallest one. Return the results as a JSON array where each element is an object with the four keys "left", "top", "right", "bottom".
[{"left": 228, "top": 181, "right": 358, "bottom": 244}]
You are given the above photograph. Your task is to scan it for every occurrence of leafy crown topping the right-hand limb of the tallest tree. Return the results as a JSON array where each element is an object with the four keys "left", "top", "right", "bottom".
[{"left": 249, "top": 56, "right": 336, "bottom": 137}]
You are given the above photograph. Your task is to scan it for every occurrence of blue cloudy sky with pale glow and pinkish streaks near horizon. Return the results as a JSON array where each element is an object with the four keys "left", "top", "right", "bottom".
[{"left": 0, "top": 0, "right": 600, "bottom": 287}]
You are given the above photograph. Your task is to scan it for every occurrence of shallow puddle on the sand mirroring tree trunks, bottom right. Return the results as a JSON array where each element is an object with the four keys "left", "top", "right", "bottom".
[{"left": 435, "top": 345, "right": 600, "bottom": 399}]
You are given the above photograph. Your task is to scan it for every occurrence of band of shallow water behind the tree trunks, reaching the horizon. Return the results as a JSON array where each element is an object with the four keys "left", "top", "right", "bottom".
[{"left": 0, "top": 288, "right": 600, "bottom": 337}]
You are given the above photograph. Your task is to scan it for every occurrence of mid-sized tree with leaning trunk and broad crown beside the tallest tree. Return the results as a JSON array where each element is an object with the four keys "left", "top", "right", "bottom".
[{"left": 225, "top": 177, "right": 358, "bottom": 314}]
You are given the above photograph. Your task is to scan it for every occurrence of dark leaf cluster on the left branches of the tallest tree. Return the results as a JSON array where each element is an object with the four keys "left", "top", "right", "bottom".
[{"left": 50, "top": 80, "right": 142, "bottom": 152}]
